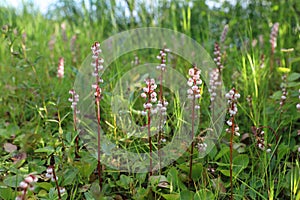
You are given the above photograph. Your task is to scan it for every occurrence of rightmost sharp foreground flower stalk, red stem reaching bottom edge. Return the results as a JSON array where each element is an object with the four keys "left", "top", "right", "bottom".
[{"left": 225, "top": 88, "right": 241, "bottom": 200}]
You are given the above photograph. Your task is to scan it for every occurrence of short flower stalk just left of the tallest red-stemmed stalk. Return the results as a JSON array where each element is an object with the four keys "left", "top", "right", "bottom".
[{"left": 69, "top": 89, "right": 80, "bottom": 158}]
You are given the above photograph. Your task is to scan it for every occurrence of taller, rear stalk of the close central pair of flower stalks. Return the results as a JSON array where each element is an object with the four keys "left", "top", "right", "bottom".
[{"left": 156, "top": 48, "right": 170, "bottom": 170}]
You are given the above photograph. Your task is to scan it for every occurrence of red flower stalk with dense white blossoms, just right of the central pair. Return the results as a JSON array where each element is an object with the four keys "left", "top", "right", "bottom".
[{"left": 187, "top": 66, "right": 202, "bottom": 181}]
